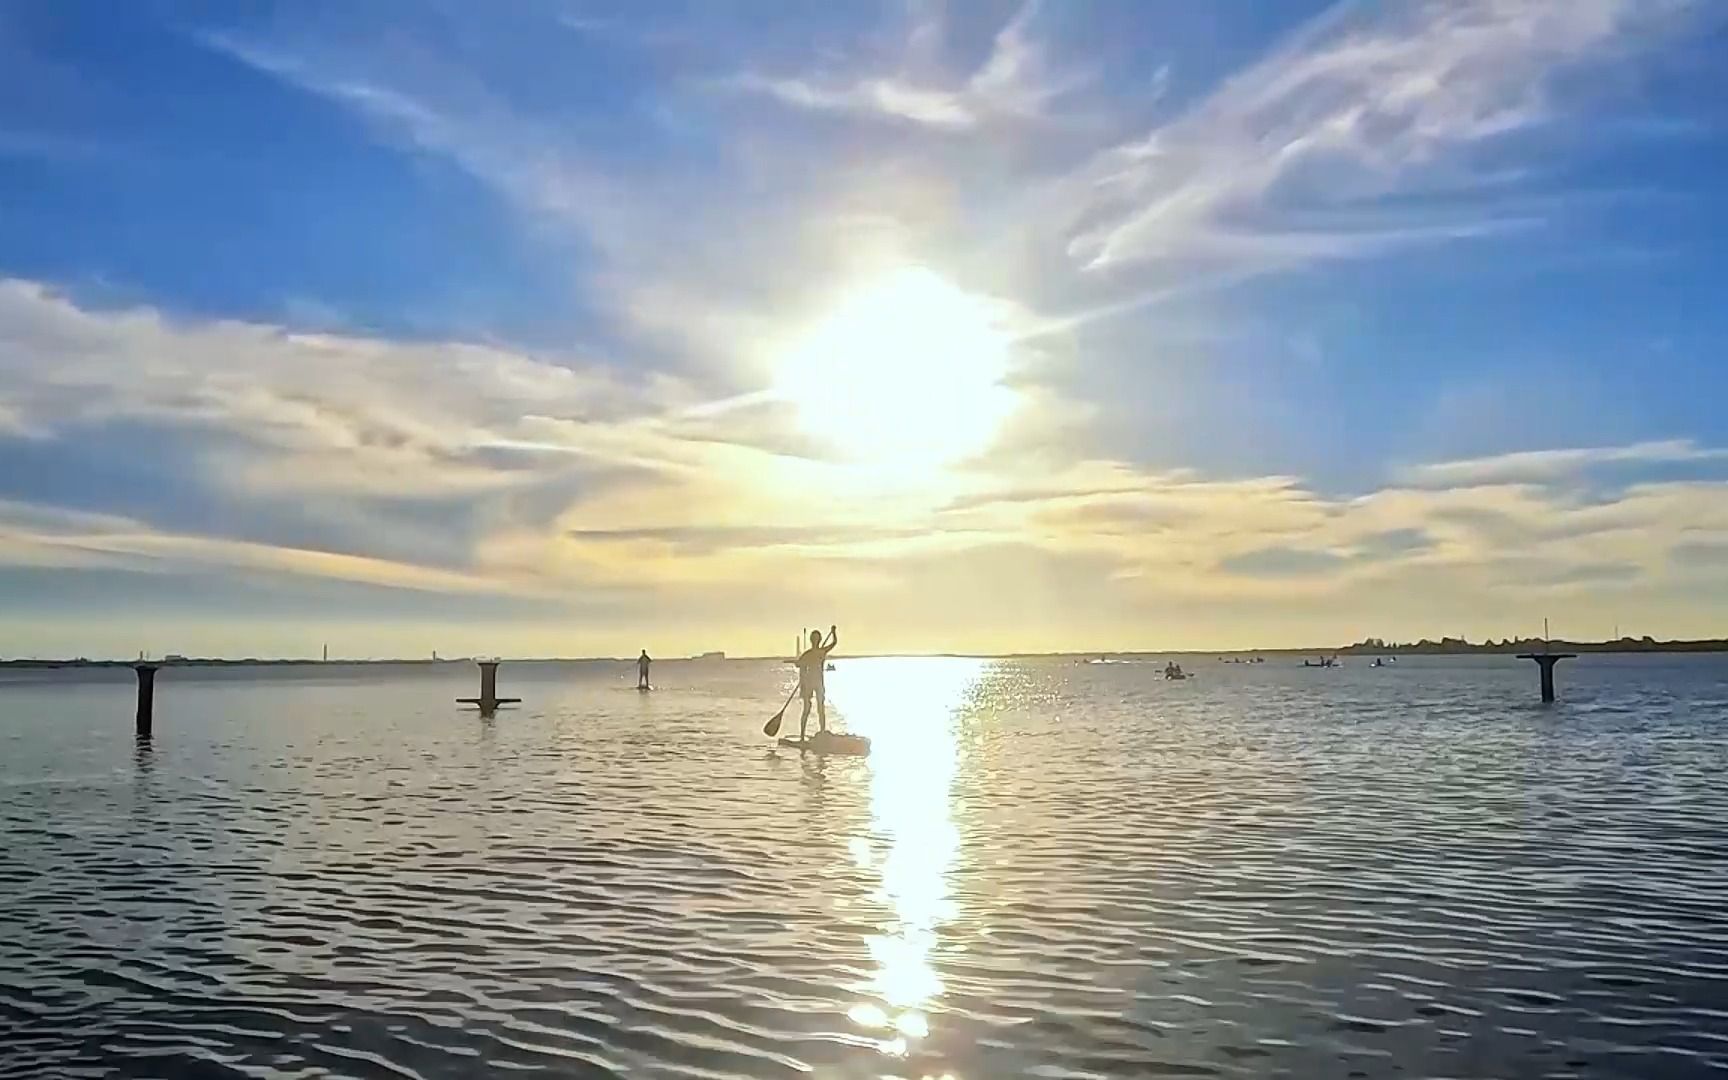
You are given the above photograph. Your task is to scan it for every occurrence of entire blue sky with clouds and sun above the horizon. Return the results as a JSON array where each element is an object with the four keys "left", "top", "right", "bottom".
[{"left": 0, "top": 0, "right": 1728, "bottom": 657}]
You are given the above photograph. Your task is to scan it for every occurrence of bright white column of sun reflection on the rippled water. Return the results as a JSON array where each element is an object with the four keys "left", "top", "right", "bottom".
[{"left": 829, "top": 657, "right": 985, "bottom": 1056}]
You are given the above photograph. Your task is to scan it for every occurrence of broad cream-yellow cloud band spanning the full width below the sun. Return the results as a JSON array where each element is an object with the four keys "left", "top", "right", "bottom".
[{"left": 0, "top": 282, "right": 1728, "bottom": 648}]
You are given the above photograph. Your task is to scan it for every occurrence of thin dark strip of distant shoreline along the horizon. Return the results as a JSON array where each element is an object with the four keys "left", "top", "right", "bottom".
[{"left": 0, "top": 638, "right": 1728, "bottom": 670}]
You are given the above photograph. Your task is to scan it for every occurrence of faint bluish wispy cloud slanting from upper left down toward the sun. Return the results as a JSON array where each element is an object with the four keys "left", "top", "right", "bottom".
[{"left": 204, "top": 12, "right": 867, "bottom": 387}]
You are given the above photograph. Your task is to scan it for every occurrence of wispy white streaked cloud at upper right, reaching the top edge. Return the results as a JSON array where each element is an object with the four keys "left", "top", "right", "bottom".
[{"left": 1063, "top": 0, "right": 1693, "bottom": 268}]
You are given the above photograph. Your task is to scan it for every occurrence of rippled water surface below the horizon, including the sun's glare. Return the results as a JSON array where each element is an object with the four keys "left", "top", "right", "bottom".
[{"left": 0, "top": 657, "right": 1728, "bottom": 1080}]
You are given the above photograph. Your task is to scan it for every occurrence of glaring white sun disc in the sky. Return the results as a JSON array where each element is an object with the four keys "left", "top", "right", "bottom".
[{"left": 774, "top": 266, "right": 1014, "bottom": 470}]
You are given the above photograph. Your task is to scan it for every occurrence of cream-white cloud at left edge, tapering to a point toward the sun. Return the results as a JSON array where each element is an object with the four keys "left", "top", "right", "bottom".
[{"left": 0, "top": 280, "right": 657, "bottom": 496}]
